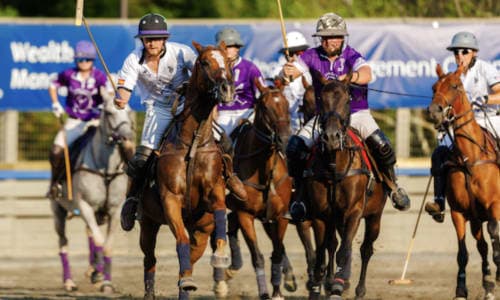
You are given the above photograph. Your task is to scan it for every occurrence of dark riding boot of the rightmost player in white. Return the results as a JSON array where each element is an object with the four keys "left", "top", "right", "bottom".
[{"left": 425, "top": 146, "right": 450, "bottom": 223}]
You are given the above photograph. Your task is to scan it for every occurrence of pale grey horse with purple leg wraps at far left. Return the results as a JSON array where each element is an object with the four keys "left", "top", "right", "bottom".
[{"left": 51, "top": 89, "right": 135, "bottom": 292}]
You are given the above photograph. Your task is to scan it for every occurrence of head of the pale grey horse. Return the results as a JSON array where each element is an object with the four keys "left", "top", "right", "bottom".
[{"left": 100, "top": 87, "right": 135, "bottom": 151}]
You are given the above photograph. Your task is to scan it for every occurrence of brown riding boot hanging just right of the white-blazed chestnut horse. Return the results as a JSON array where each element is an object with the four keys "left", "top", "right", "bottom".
[{"left": 218, "top": 132, "right": 248, "bottom": 202}]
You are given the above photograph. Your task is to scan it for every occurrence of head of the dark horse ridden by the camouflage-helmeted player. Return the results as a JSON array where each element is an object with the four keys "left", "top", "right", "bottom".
[{"left": 320, "top": 76, "right": 351, "bottom": 153}]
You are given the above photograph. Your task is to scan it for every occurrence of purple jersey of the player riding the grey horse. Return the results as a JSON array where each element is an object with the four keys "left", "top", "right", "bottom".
[{"left": 52, "top": 67, "right": 106, "bottom": 121}]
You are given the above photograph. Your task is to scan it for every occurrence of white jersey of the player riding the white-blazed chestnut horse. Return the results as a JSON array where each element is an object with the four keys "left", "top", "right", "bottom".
[{"left": 118, "top": 42, "right": 196, "bottom": 105}]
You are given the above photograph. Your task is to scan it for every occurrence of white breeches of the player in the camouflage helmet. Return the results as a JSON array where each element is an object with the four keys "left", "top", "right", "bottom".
[{"left": 297, "top": 109, "right": 379, "bottom": 148}]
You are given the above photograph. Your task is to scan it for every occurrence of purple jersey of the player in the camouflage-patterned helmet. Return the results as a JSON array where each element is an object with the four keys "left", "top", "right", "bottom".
[{"left": 300, "top": 46, "right": 368, "bottom": 113}]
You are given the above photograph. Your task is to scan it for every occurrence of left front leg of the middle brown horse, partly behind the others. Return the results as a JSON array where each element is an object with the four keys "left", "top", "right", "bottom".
[{"left": 238, "top": 211, "right": 270, "bottom": 299}]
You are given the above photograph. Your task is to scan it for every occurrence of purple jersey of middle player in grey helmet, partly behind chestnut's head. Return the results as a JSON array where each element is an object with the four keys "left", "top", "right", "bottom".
[{"left": 218, "top": 57, "right": 265, "bottom": 110}]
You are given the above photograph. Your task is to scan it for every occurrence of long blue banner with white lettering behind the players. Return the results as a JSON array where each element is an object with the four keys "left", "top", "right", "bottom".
[{"left": 0, "top": 20, "right": 500, "bottom": 111}]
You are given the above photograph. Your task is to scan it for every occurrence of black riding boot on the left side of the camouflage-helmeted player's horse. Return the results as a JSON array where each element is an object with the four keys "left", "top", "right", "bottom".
[{"left": 284, "top": 135, "right": 309, "bottom": 223}]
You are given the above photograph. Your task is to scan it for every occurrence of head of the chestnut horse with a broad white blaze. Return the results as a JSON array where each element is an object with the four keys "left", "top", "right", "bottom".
[{"left": 190, "top": 41, "right": 234, "bottom": 106}]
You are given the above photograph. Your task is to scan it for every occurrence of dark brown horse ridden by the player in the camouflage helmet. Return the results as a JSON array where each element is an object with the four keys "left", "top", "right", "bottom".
[{"left": 305, "top": 77, "right": 387, "bottom": 299}]
